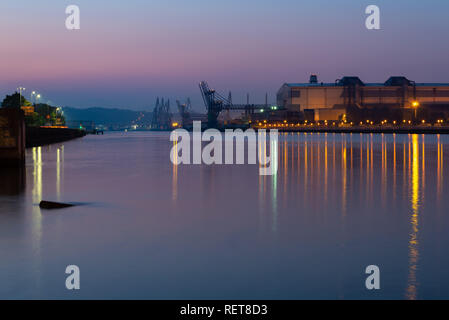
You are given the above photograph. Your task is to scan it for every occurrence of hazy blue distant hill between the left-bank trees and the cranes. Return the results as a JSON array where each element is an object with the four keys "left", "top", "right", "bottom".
[{"left": 62, "top": 107, "right": 152, "bottom": 126}]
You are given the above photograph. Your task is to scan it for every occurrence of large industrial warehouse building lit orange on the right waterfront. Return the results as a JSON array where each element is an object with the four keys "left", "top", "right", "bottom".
[{"left": 277, "top": 75, "right": 449, "bottom": 121}]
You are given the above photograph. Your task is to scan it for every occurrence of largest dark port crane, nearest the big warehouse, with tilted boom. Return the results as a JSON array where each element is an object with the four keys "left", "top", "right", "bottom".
[{"left": 199, "top": 81, "right": 271, "bottom": 128}]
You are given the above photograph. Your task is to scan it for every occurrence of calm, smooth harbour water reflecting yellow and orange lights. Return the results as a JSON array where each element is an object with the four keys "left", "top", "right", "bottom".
[{"left": 0, "top": 133, "right": 449, "bottom": 299}]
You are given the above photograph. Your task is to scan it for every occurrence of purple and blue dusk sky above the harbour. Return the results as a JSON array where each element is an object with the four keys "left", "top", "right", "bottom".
[{"left": 0, "top": 0, "right": 449, "bottom": 111}]
